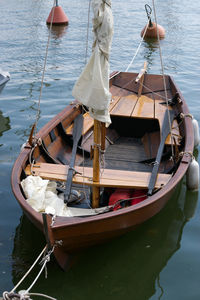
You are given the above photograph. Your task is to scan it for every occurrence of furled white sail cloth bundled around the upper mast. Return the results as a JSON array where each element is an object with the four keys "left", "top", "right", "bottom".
[{"left": 72, "top": 0, "right": 113, "bottom": 124}]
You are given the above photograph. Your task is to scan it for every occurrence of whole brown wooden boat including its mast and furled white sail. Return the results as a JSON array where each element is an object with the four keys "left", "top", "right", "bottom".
[{"left": 11, "top": 0, "right": 194, "bottom": 268}]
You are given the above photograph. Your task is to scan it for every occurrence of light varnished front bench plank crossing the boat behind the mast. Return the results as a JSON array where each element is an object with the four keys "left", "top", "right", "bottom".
[{"left": 25, "top": 163, "right": 171, "bottom": 189}]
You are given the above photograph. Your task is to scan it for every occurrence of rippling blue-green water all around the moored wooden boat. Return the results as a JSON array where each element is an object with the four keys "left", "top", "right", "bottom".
[{"left": 0, "top": 0, "right": 200, "bottom": 300}]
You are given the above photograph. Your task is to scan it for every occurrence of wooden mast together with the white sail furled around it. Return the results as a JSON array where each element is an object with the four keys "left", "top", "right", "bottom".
[{"left": 72, "top": 0, "right": 113, "bottom": 208}]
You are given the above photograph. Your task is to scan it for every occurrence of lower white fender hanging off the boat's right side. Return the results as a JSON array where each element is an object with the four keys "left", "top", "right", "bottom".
[{"left": 186, "top": 157, "right": 199, "bottom": 190}]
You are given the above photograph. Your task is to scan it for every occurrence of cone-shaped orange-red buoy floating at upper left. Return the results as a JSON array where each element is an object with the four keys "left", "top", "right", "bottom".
[{"left": 46, "top": 2, "right": 69, "bottom": 25}]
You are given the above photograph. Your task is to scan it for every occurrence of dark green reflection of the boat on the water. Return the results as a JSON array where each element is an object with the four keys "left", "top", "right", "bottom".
[{"left": 12, "top": 182, "right": 198, "bottom": 300}]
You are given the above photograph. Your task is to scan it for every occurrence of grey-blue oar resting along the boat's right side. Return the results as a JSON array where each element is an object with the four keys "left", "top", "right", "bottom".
[{"left": 147, "top": 110, "right": 175, "bottom": 196}]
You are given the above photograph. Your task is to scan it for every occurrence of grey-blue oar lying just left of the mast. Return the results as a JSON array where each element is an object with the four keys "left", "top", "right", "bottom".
[{"left": 64, "top": 114, "right": 83, "bottom": 203}]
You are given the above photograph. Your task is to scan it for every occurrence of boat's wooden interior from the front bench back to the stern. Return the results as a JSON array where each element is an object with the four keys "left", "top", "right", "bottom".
[{"left": 24, "top": 73, "right": 183, "bottom": 210}]
